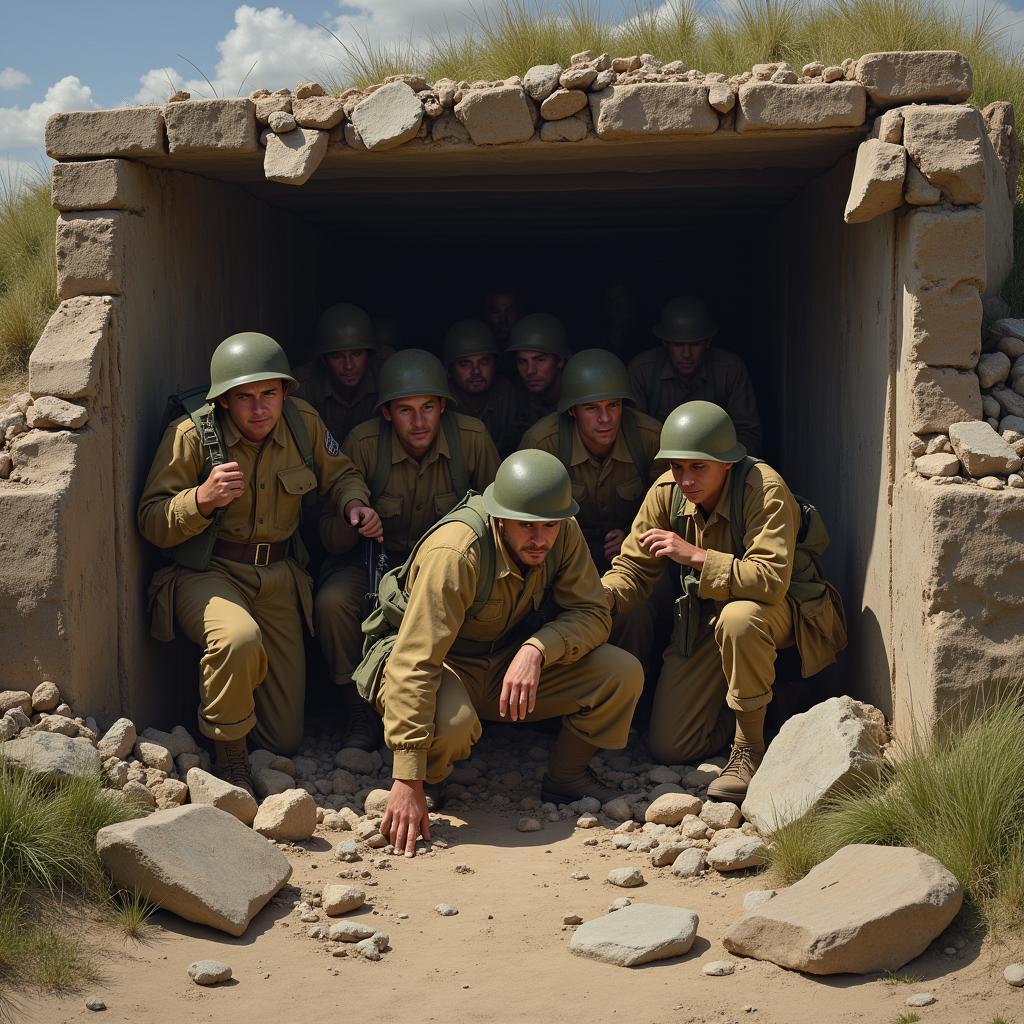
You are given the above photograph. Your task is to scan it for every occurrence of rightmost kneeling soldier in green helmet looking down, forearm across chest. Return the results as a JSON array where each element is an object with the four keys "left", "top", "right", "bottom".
[{"left": 602, "top": 401, "right": 801, "bottom": 803}]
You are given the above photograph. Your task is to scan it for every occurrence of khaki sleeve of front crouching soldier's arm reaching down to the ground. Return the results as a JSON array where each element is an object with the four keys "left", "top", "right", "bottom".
[{"left": 384, "top": 524, "right": 479, "bottom": 780}]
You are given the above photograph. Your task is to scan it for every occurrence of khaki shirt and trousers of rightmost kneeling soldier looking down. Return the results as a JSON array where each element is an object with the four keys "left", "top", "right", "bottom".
[{"left": 601, "top": 463, "right": 800, "bottom": 764}]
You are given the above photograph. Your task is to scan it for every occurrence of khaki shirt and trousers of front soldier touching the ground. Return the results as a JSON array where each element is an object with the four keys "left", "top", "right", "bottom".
[{"left": 377, "top": 519, "right": 643, "bottom": 782}]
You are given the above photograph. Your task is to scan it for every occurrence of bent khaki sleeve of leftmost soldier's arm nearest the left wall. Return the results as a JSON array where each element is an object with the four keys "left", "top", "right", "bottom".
[{"left": 138, "top": 423, "right": 210, "bottom": 548}]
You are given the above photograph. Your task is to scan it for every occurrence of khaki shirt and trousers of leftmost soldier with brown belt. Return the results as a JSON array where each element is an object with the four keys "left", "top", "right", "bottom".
[{"left": 138, "top": 399, "right": 370, "bottom": 752}]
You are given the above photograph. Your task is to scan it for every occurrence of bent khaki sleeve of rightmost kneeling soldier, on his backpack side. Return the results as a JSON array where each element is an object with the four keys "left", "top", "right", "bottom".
[{"left": 698, "top": 475, "right": 800, "bottom": 604}]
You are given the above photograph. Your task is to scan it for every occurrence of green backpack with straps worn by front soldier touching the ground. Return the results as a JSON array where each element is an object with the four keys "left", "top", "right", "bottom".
[{"left": 352, "top": 490, "right": 563, "bottom": 703}]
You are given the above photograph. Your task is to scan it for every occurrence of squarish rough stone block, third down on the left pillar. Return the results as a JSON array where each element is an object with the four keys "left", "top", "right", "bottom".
[{"left": 56, "top": 211, "right": 132, "bottom": 299}]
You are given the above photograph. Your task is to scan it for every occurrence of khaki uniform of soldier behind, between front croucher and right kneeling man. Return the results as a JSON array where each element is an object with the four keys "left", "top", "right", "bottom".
[{"left": 519, "top": 413, "right": 672, "bottom": 664}]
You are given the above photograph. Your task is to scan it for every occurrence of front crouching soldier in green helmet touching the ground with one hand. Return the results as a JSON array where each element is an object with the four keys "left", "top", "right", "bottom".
[{"left": 360, "top": 452, "right": 643, "bottom": 856}]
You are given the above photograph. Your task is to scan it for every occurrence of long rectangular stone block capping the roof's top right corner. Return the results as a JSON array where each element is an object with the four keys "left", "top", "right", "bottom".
[{"left": 855, "top": 50, "right": 974, "bottom": 106}]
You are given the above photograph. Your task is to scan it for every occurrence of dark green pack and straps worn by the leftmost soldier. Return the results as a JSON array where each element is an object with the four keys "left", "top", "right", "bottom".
[{"left": 161, "top": 387, "right": 315, "bottom": 572}]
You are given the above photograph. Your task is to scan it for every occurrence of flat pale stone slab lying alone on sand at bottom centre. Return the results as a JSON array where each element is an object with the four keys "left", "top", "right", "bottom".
[{"left": 569, "top": 903, "right": 700, "bottom": 967}]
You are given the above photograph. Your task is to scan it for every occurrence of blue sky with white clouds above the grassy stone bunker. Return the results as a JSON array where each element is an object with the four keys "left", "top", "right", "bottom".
[{"left": 0, "top": 0, "right": 1024, "bottom": 174}]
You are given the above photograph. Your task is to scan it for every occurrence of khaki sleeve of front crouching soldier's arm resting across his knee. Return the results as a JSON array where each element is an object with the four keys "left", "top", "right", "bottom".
[{"left": 526, "top": 519, "right": 611, "bottom": 665}]
